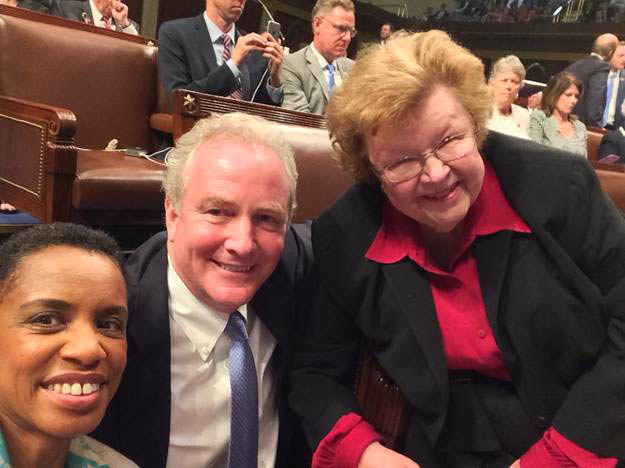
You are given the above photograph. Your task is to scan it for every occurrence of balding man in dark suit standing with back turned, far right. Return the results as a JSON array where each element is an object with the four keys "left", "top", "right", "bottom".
[{"left": 566, "top": 33, "right": 618, "bottom": 127}]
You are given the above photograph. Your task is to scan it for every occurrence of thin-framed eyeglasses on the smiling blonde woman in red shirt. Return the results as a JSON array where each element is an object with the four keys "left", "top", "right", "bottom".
[{"left": 373, "top": 131, "right": 477, "bottom": 184}]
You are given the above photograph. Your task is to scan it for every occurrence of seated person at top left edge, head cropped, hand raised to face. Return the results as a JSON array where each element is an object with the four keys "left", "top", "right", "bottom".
[{"left": 57, "top": 0, "right": 139, "bottom": 36}]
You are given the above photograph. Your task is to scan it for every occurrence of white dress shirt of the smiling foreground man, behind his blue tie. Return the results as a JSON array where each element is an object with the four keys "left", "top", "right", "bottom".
[{"left": 167, "top": 259, "right": 278, "bottom": 468}]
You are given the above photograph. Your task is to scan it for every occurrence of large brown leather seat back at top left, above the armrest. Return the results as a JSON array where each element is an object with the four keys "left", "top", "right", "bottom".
[{"left": 0, "top": 7, "right": 158, "bottom": 149}]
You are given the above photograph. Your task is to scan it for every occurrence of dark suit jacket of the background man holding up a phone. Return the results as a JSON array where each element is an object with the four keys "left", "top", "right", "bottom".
[{"left": 158, "top": 14, "right": 282, "bottom": 106}]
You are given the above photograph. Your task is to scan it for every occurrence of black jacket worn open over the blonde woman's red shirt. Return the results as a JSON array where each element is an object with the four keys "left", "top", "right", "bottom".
[{"left": 289, "top": 133, "right": 625, "bottom": 468}]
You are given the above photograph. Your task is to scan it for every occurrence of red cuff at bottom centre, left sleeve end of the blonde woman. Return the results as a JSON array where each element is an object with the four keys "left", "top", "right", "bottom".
[{"left": 312, "top": 413, "right": 381, "bottom": 468}]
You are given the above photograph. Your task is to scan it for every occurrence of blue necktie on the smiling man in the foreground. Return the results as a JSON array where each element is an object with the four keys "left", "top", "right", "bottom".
[{"left": 226, "top": 311, "right": 258, "bottom": 468}]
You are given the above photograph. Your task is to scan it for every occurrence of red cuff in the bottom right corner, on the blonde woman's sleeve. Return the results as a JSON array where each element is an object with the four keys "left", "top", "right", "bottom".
[{"left": 521, "top": 427, "right": 618, "bottom": 468}]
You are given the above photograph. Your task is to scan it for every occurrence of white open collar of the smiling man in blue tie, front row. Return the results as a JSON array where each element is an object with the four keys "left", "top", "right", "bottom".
[{"left": 167, "top": 256, "right": 255, "bottom": 361}]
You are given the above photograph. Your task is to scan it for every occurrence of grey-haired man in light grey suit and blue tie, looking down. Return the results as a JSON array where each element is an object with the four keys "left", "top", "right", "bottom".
[{"left": 282, "top": 0, "right": 356, "bottom": 114}]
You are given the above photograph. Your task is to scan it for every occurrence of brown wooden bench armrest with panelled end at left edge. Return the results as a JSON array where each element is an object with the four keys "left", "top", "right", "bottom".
[{"left": 0, "top": 96, "right": 77, "bottom": 222}]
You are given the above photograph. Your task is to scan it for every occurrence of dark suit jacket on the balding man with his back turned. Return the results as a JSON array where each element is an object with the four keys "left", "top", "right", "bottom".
[{"left": 566, "top": 55, "right": 610, "bottom": 127}]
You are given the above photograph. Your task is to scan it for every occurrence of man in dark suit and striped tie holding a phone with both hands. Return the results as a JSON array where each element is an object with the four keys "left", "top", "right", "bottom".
[{"left": 158, "top": 0, "right": 283, "bottom": 106}]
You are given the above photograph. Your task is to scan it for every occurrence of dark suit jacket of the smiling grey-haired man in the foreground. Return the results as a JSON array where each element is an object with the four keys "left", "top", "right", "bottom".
[{"left": 93, "top": 225, "right": 312, "bottom": 468}]
